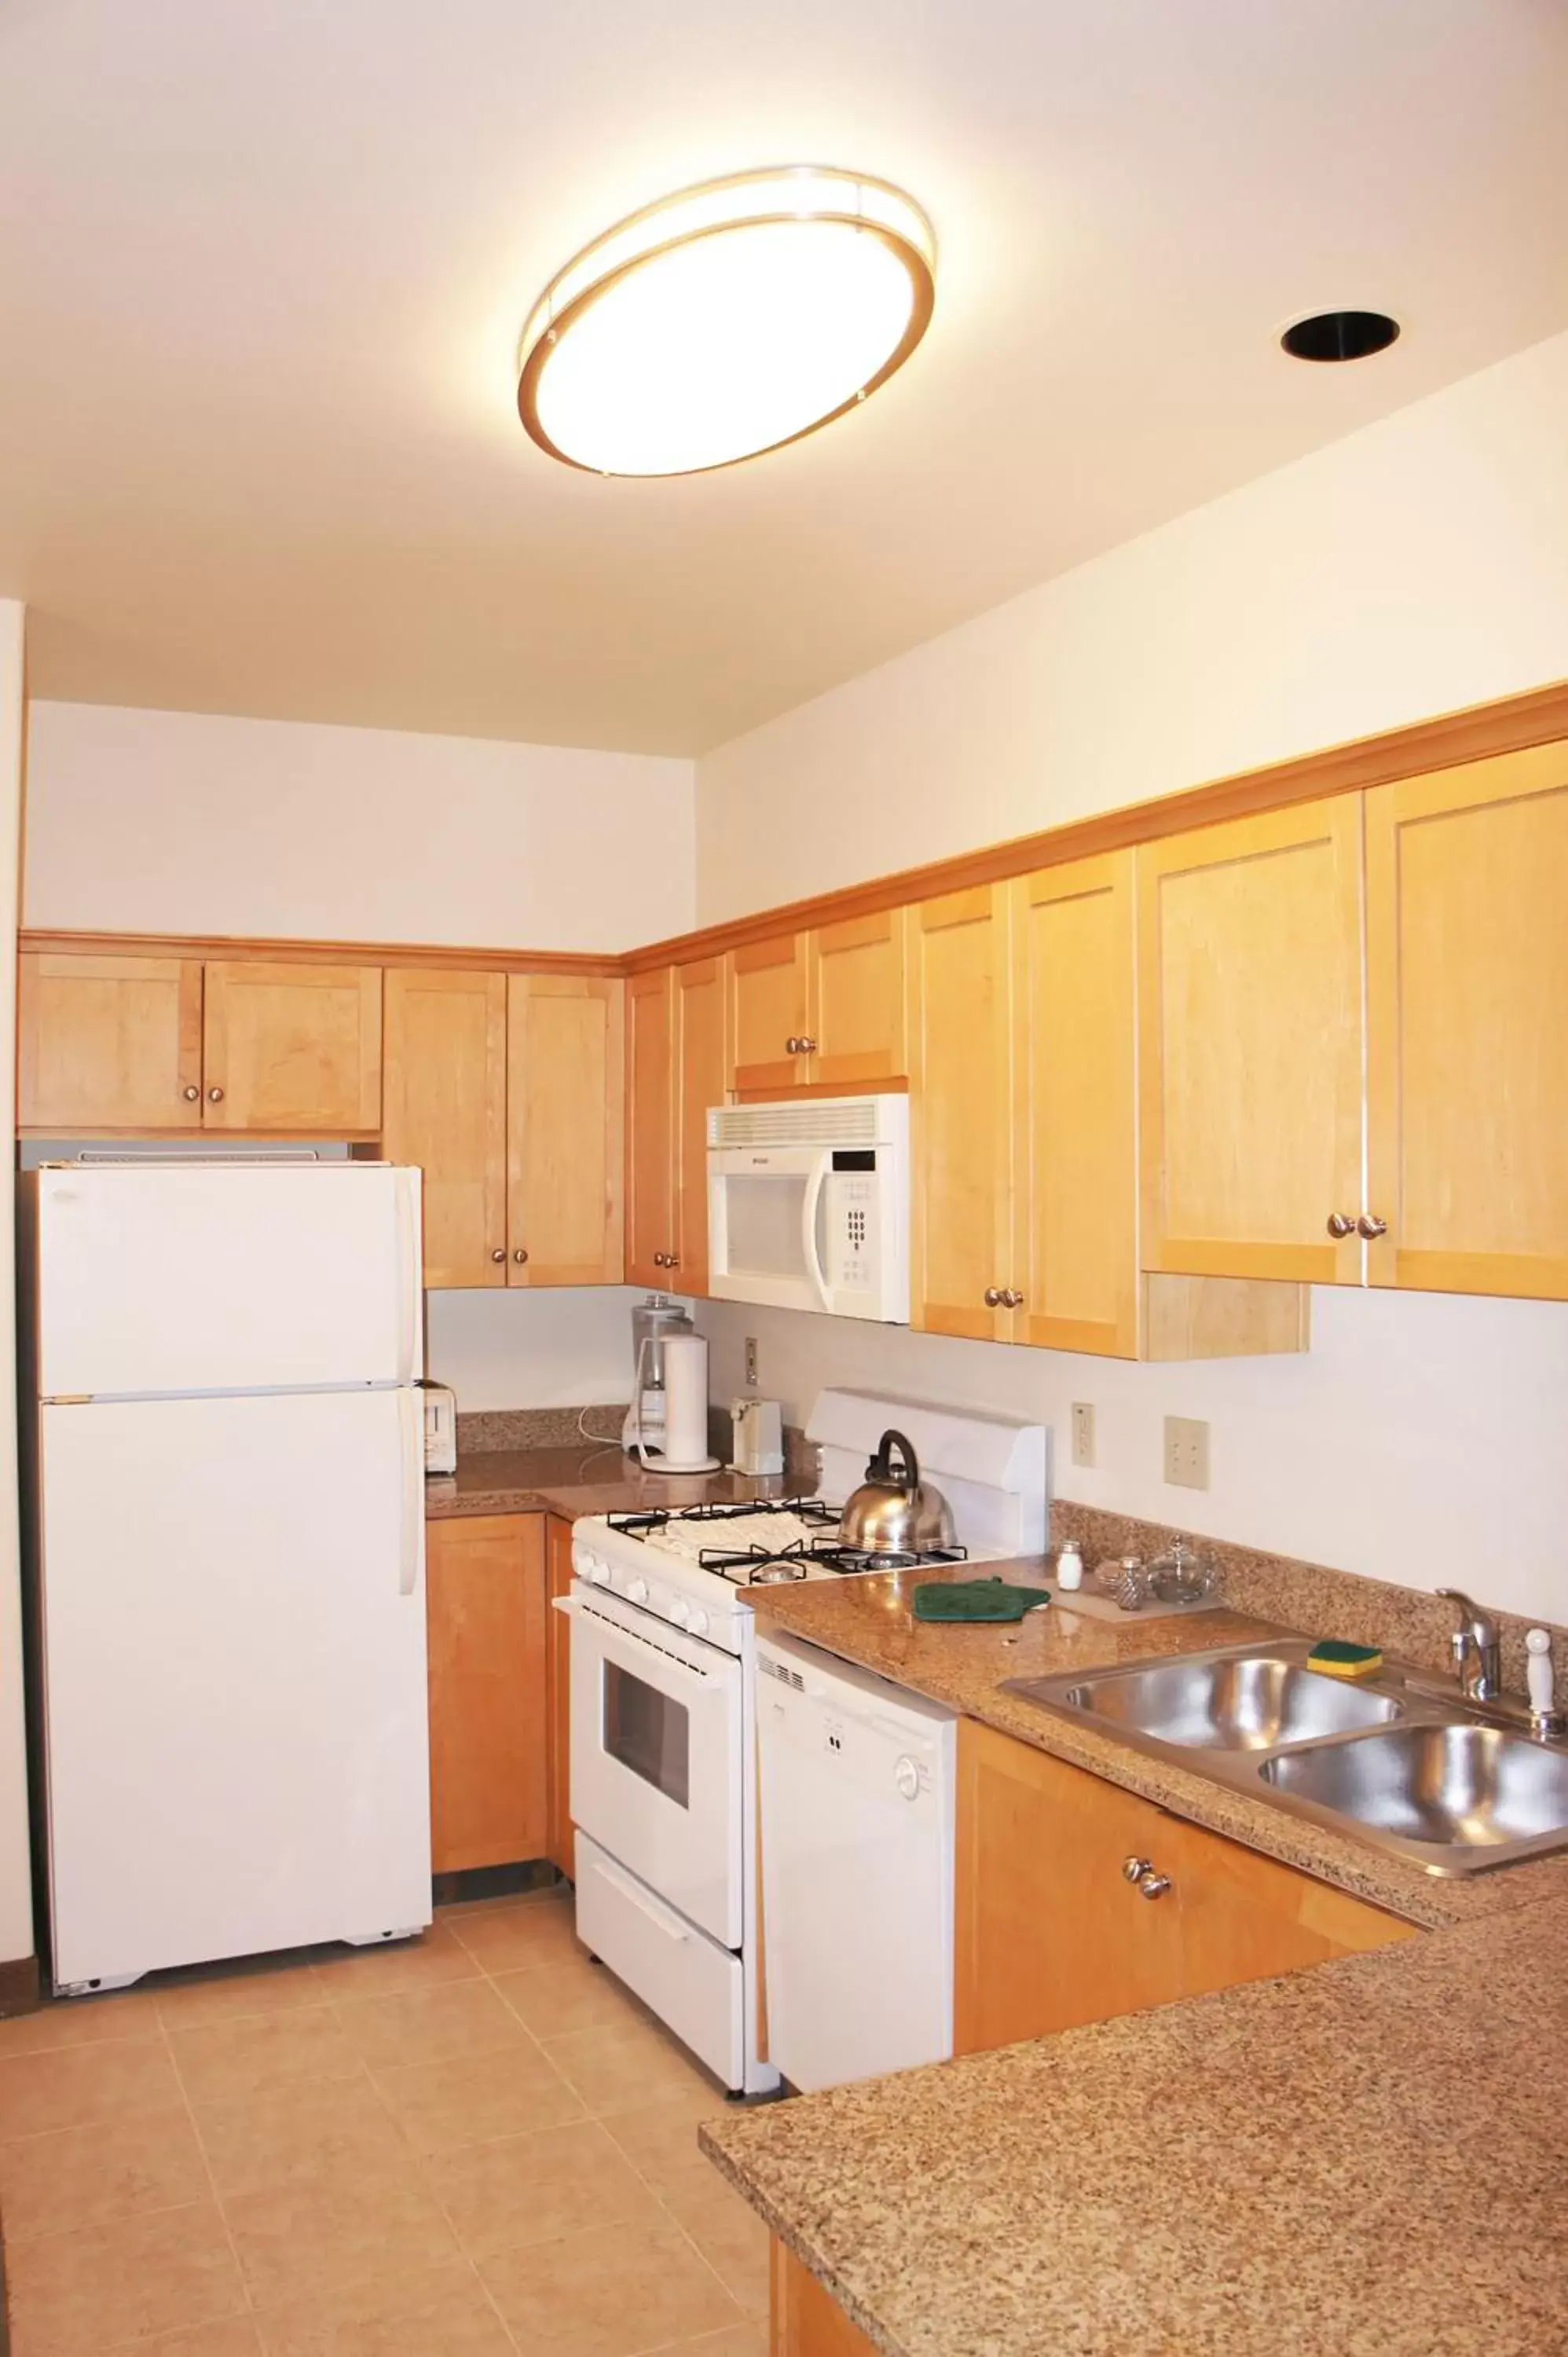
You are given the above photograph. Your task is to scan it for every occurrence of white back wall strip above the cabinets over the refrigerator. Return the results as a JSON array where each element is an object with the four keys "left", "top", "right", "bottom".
[{"left": 24, "top": 702, "right": 693, "bottom": 950}]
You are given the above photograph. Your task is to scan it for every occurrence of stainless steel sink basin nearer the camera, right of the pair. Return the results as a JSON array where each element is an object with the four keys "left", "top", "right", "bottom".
[{"left": 1257, "top": 1725, "right": 1568, "bottom": 1850}]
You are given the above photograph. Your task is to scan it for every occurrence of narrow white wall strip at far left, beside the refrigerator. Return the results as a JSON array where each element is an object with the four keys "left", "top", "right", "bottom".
[{"left": 0, "top": 599, "right": 33, "bottom": 1961}]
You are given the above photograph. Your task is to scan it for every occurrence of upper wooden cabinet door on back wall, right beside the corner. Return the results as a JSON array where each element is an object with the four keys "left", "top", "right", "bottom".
[{"left": 507, "top": 973, "right": 625, "bottom": 1285}]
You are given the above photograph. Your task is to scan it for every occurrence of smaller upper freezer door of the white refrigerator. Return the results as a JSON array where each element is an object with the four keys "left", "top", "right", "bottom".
[{"left": 38, "top": 1162, "right": 424, "bottom": 1398}]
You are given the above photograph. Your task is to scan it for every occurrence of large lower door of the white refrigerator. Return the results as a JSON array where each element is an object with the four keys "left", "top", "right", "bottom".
[{"left": 40, "top": 1391, "right": 431, "bottom": 1987}]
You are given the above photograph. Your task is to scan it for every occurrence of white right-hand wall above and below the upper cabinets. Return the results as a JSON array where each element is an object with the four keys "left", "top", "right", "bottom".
[{"left": 698, "top": 337, "right": 1568, "bottom": 1622}]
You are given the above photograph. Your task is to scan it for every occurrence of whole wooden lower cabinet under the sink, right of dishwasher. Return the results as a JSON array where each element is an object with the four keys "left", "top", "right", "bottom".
[{"left": 953, "top": 1718, "right": 1415, "bottom": 2053}]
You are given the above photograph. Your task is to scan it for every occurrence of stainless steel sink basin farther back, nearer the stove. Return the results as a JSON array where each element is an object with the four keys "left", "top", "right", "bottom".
[{"left": 1061, "top": 1652, "right": 1398, "bottom": 1751}]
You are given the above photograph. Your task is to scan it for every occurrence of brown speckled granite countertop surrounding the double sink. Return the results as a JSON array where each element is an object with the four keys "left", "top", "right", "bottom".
[{"left": 749, "top": 1556, "right": 1568, "bottom": 1930}]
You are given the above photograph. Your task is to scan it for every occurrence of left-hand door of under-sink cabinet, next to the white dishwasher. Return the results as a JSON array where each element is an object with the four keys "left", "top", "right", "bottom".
[{"left": 953, "top": 1718, "right": 1181, "bottom": 2053}]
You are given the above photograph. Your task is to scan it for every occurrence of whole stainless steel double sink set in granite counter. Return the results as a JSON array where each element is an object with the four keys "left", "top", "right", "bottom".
[{"left": 1007, "top": 1638, "right": 1568, "bottom": 1874}]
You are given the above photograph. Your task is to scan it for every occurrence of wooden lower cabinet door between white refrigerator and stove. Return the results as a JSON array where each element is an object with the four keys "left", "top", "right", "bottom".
[{"left": 424, "top": 1513, "right": 549, "bottom": 1874}]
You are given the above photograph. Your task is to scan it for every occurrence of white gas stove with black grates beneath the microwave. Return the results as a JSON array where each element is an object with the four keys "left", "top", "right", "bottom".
[{"left": 563, "top": 1391, "right": 1047, "bottom": 2093}]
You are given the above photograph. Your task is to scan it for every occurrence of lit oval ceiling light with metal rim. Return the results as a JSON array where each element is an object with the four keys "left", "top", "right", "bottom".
[{"left": 516, "top": 165, "right": 936, "bottom": 474}]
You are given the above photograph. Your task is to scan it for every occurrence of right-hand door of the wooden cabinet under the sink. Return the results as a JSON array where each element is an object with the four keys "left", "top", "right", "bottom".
[{"left": 1169, "top": 1820, "right": 1417, "bottom": 1996}]
